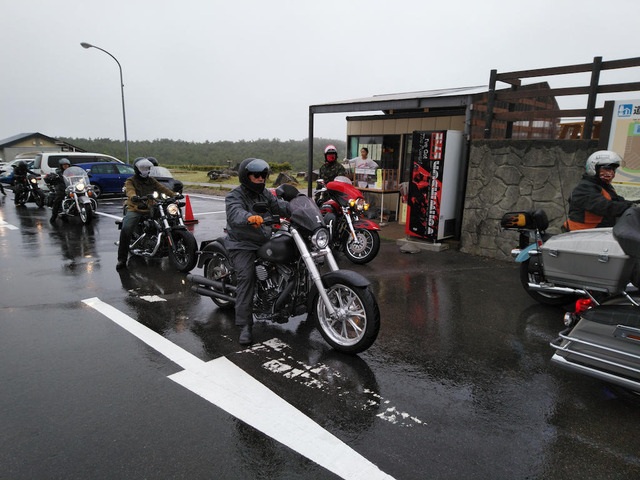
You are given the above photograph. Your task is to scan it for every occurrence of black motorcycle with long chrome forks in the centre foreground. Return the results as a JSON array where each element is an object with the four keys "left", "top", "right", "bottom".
[{"left": 187, "top": 191, "right": 380, "bottom": 354}]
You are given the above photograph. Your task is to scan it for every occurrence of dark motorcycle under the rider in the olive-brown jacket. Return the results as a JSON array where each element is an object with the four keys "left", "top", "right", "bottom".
[{"left": 116, "top": 192, "right": 198, "bottom": 272}]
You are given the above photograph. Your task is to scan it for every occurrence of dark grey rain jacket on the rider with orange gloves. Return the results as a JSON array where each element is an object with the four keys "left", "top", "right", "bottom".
[{"left": 224, "top": 185, "right": 291, "bottom": 250}]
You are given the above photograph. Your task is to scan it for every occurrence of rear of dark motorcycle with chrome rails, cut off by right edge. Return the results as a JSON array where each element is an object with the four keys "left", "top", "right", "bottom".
[{"left": 551, "top": 207, "right": 640, "bottom": 401}]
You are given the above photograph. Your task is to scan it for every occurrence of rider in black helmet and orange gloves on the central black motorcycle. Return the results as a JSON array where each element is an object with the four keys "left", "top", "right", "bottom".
[{"left": 225, "top": 158, "right": 291, "bottom": 345}]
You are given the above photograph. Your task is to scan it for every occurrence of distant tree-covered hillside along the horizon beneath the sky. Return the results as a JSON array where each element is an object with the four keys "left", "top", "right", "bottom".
[{"left": 61, "top": 138, "right": 346, "bottom": 171}]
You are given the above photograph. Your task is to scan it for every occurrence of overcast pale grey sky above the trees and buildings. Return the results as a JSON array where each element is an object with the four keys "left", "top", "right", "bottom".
[{"left": 5, "top": 0, "right": 640, "bottom": 142}]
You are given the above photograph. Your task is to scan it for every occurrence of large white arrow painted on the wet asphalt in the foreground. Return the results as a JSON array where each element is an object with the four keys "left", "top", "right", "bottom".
[{"left": 83, "top": 297, "right": 393, "bottom": 480}]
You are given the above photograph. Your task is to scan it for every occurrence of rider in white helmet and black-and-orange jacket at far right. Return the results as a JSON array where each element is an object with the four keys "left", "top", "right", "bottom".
[{"left": 562, "top": 150, "right": 633, "bottom": 232}]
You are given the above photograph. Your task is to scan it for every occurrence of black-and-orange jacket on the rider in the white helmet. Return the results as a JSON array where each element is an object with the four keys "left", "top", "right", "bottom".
[{"left": 563, "top": 174, "right": 633, "bottom": 231}]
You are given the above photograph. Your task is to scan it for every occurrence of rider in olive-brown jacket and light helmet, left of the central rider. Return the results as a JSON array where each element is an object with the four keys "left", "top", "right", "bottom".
[{"left": 116, "top": 157, "right": 176, "bottom": 270}]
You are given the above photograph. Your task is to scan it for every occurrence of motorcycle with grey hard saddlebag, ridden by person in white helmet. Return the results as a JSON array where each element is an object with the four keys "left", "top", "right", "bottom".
[{"left": 501, "top": 209, "right": 640, "bottom": 305}]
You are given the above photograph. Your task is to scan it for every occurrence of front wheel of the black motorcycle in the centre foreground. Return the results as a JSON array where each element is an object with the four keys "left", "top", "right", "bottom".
[{"left": 315, "top": 279, "right": 380, "bottom": 354}]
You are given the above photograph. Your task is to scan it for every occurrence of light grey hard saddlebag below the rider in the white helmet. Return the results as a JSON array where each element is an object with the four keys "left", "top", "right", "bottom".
[{"left": 541, "top": 228, "right": 635, "bottom": 293}]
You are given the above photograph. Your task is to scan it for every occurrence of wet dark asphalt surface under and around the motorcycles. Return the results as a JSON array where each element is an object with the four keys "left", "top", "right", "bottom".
[{"left": 0, "top": 193, "right": 640, "bottom": 479}]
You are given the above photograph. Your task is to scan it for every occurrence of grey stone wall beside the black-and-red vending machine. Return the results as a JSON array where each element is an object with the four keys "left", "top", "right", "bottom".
[{"left": 460, "top": 140, "right": 598, "bottom": 260}]
